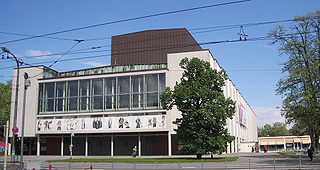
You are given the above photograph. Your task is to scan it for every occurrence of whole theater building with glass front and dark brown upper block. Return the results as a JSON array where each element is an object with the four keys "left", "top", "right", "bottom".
[{"left": 10, "top": 29, "right": 257, "bottom": 156}]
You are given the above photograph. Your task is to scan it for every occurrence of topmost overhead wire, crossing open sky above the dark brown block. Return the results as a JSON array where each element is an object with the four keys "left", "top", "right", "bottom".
[{"left": 0, "top": 0, "right": 252, "bottom": 44}]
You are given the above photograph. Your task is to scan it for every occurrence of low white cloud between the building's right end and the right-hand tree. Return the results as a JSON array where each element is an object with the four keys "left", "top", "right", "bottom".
[{"left": 253, "top": 107, "right": 285, "bottom": 127}]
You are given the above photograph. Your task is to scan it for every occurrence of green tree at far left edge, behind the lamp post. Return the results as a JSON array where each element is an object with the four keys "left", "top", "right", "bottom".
[{"left": 0, "top": 81, "right": 11, "bottom": 126}]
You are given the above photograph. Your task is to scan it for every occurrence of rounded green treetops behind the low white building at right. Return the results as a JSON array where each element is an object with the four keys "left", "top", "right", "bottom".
[{"left": 258, "top": 122, "right": 291, "bottom": 137}]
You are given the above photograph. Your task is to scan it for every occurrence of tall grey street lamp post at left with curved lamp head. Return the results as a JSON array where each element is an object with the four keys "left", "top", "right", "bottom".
[{"left": 1, "top": 47, "right": 23, "bottom": 158}]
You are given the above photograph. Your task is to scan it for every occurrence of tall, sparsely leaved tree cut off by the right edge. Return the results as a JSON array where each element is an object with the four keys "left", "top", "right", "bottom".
[{"left": 269, "top": 11, "right": 320, "bottom": 148}]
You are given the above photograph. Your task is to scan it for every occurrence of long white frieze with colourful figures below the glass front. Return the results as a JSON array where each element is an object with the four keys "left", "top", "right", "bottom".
[{"left": 36, "top": 115, "right": 166, "bottom": 132}]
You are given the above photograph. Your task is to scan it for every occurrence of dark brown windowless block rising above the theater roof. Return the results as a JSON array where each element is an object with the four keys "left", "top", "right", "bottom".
[{"left": 111, "top": 28, "right": 202, "bottom": 65}]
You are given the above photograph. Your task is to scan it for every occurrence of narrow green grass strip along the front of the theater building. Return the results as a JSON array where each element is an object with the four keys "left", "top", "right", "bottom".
[{"left": 51, "top": 157, "right": 239, "bottom": 163}]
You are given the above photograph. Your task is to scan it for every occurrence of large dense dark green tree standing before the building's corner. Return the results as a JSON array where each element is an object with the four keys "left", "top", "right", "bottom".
[{"left": 161, "top": 58, "right": 235, "bottom": 159}]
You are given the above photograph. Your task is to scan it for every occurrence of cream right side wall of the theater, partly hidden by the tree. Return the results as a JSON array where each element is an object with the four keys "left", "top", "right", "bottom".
[{"left": 167, "top": 50, "right": 258, "bottom": 152}]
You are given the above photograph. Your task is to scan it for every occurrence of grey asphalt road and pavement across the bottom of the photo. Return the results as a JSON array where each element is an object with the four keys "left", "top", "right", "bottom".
[{"left": 0, "top": 153, "right": 320, "bottom": 170}]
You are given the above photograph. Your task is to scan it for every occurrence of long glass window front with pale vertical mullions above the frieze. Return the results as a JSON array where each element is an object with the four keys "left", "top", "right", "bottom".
[{"left": 38, "top": 73, "right": 165, "bottom": 114}]
